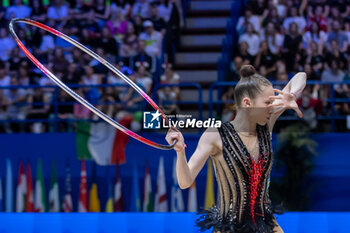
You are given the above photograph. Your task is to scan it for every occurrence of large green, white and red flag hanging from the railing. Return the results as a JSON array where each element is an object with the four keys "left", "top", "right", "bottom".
[{"left": 76, "top": 119, "right": 132, "bottom": 165}]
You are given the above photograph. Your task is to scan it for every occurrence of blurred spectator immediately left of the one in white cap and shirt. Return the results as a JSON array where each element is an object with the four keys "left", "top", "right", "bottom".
[{"left": 119, "top": 23, "right": 140, "bottom": 60}]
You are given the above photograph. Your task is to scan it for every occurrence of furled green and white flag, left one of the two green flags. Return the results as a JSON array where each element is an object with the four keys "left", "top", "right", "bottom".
[{"left": 34, "top": 159, "right": 46, "bottom": 212}]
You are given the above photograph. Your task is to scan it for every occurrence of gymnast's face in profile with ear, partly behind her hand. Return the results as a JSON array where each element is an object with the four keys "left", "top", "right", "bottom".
[{"left": 243, "top": 85, "right": 274, "bottom": 125}]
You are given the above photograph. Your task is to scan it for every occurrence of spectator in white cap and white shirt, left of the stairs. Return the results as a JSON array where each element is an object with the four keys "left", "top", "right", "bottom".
[{"left": 140, "top": 20, "right": 162, "bottom": 57}]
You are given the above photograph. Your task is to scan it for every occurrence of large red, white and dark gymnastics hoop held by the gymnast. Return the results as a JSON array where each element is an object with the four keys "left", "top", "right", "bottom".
[{"left": 9, "top": 18, "right": 177, "bottom": 150}]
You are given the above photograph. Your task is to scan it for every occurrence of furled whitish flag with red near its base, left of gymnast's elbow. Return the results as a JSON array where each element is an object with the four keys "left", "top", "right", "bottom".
[{"left": 154, "top": 157, "right": 168, "bottom": 212}]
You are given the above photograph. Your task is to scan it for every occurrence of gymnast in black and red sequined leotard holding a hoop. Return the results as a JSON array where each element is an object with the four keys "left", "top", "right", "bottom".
[{"left": 166, "top": 65, "right": 306, "bottom": 233}]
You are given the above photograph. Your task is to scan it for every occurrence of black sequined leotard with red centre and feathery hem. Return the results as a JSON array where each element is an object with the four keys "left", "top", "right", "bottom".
[{"left": 197, "top": 122, "right": 277, "bottom": 233}]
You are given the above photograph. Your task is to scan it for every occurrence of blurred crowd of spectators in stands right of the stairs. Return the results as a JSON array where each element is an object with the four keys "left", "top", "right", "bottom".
[{"left": 224, "top": 0, "right": 350, "bottom": 131}]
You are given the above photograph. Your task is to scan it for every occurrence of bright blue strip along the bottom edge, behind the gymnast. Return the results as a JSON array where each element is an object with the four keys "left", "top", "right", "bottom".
[{"left": 0, "top": 212, "right": 350, "bottom": 233}]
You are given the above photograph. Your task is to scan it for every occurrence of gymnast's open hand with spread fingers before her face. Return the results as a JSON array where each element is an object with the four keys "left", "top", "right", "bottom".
[{"left": 268, "top": 89, "right": 303, "bottom": 118}]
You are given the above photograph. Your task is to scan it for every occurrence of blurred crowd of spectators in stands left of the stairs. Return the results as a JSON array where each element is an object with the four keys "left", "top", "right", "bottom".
[{"left": 0, "top": 0, "right": 183, "bottom": 132}]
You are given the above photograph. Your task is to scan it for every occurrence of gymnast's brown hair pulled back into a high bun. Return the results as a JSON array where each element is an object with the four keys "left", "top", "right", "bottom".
[{"left": 234, "top": 65, "right": 272, "bottom": 106}]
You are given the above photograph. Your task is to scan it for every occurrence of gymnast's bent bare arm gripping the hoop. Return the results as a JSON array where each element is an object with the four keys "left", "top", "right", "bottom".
[{"left": 165, "top": 128, "right": 220, "bottom": 189}]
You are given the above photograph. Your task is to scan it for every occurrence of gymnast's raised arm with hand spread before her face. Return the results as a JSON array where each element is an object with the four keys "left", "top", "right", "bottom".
[{"left": 269, "top": 72, "right": 306, "bottom": 132}]
